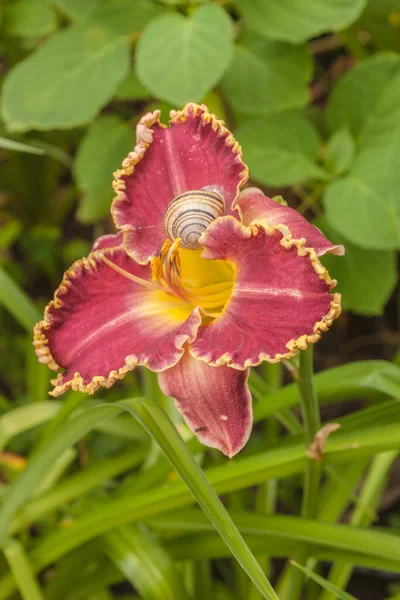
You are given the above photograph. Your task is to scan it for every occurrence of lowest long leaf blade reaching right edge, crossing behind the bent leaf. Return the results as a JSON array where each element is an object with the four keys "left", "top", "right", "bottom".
[{"left": 154, "top": 508, "right": 399, "bottom": 570}]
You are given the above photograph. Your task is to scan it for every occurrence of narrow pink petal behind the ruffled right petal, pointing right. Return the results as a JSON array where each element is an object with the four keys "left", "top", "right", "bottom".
[{"left": 237, "top": 188, "right": 344, "bottom": 256}]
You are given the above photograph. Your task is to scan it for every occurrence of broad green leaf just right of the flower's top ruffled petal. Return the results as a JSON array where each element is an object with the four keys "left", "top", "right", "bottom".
[{"left": 236, "top": 112, "right": 326, "bottom": 187}]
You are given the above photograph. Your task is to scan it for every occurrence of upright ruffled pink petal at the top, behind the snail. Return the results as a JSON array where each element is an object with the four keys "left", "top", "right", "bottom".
[{"left": 111, "top": 104, "right": 248, "bottom": 263}]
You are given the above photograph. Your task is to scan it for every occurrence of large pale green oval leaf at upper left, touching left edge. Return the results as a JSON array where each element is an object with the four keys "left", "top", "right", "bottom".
[{"left": 2, "top": 26, "right": 129, "bottom": 131}]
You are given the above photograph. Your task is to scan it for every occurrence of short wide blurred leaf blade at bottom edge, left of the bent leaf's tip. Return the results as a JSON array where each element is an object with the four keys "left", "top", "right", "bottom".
[{"left": 104, "top": 526, "right": 188, "bottom": 600}]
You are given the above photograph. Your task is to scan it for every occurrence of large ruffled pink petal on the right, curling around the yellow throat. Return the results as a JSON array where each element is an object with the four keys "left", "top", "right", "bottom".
[{"left": 190, "top": 217, "right": 340, "bottom": 369}]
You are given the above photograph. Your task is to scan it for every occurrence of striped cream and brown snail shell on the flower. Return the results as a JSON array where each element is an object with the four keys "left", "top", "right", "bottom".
[{"left": 164, "top": 190, "right": 225, "bottom": 250}]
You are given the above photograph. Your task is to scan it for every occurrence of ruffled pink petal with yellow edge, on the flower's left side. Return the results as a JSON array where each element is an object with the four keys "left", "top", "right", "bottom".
[{"left": 34, "top": 247, "right": 201, "bottom": 396}]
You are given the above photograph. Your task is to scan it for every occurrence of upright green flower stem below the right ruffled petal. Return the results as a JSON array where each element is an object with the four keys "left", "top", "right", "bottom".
[{"left": 279, "top": 345, "right": 321, "bottom": 600}]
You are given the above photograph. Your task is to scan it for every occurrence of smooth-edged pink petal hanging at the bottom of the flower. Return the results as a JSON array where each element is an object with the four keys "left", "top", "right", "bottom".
[{"left": 158, "top": 352, "right": 252, "bottom": 458}]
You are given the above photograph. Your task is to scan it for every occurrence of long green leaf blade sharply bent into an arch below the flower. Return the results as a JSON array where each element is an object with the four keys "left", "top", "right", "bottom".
[{"left": 0, "top": 399, "right": 277, "bottom": 600}]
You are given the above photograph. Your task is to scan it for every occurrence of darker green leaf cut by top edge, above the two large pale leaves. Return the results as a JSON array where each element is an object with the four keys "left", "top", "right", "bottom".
[{"left": 90, "top": 0, "right": 160, "bottom": 36}]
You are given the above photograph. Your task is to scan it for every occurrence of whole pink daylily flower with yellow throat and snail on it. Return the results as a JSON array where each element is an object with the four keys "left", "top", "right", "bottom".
[{"left": 34, "top": 104, "right": 343, "bottom": 456}]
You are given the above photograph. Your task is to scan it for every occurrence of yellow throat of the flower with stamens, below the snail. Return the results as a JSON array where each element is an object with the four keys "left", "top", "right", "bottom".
[{"left": 151, "top": 238, "right": 235, "bottom": 318}]
